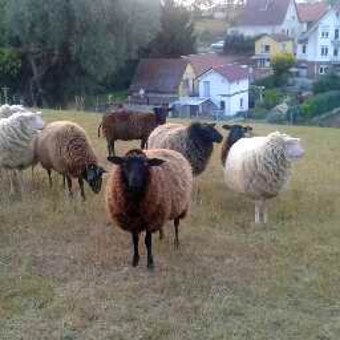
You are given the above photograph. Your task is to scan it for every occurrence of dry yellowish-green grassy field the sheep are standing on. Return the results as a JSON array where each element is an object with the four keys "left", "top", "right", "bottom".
[{"left": 0, "top": 112, "right": 340, "bottom": 340}]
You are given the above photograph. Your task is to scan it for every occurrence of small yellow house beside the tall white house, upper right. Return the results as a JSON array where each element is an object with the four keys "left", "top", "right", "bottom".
[{"left": 253, "top": 34, "right": 294, "bottom": 68}]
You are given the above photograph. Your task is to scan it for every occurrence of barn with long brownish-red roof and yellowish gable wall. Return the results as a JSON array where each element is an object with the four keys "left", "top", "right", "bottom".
[{"left": 129, "top": 59, "right": 196, "bottom": 105}]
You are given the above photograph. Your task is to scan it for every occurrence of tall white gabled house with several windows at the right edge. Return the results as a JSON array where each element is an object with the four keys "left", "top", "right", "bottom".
[{"left": 296, "top": 6, "right": 340, "bottom": 78}]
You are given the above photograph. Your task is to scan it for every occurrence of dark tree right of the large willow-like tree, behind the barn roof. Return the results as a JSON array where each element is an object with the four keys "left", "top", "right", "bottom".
[{"left": 149, "top": 0, "right": 196, "bottom": 58}]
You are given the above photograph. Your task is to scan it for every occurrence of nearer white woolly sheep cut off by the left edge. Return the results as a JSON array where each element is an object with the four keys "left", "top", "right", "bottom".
[{"left": 0, "top": 111, "right": 45, "bottom": 193}]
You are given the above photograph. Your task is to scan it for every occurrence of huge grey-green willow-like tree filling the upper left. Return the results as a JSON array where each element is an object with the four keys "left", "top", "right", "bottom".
[{"left": 2, "top": 0, "right": 159, "bottom": 106}]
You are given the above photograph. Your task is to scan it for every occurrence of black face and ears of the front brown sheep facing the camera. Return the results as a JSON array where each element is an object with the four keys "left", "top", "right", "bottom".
[{"left": 107, "top": 153, "right": 164, "bottom": 197}]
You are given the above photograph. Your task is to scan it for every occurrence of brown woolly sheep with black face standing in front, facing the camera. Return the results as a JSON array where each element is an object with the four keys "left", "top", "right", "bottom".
[{"left": 106, "top": 149, "right": 193, "bottom": 269}]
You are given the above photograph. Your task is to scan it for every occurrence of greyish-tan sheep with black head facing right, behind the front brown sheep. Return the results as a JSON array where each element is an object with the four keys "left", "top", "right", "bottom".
[{"left": 148, "top": 122, "right": 223, "bottom": 177}]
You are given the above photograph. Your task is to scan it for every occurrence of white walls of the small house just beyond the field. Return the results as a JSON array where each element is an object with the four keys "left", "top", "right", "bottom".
[{"left": 199, "top": 71, "right": 249, "bottom": 116}]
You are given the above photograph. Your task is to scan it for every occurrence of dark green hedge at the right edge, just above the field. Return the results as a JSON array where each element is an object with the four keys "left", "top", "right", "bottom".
[{"left": 302, "top": 91, "right": 340, "bottom": 119}]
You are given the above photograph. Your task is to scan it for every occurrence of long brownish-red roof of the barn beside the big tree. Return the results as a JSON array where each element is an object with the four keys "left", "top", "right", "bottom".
[{"left": 130, "top": 59, "right": 188, "bottom": 93}]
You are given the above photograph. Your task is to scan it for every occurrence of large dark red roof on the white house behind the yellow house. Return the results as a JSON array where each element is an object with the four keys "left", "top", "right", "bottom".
[{"left": 238, "top": 0, "right": 290, "bottom": 26}]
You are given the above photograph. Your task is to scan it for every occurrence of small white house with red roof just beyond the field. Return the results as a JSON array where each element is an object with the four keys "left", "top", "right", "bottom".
[{"left": 197, "top": 64, "right": 249, "bottom": 116}]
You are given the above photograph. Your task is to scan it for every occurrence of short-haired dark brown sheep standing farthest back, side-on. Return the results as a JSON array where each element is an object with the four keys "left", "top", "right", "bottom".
[{"left": 98, "top": 105, "right": 170, "bottom": 156}]
